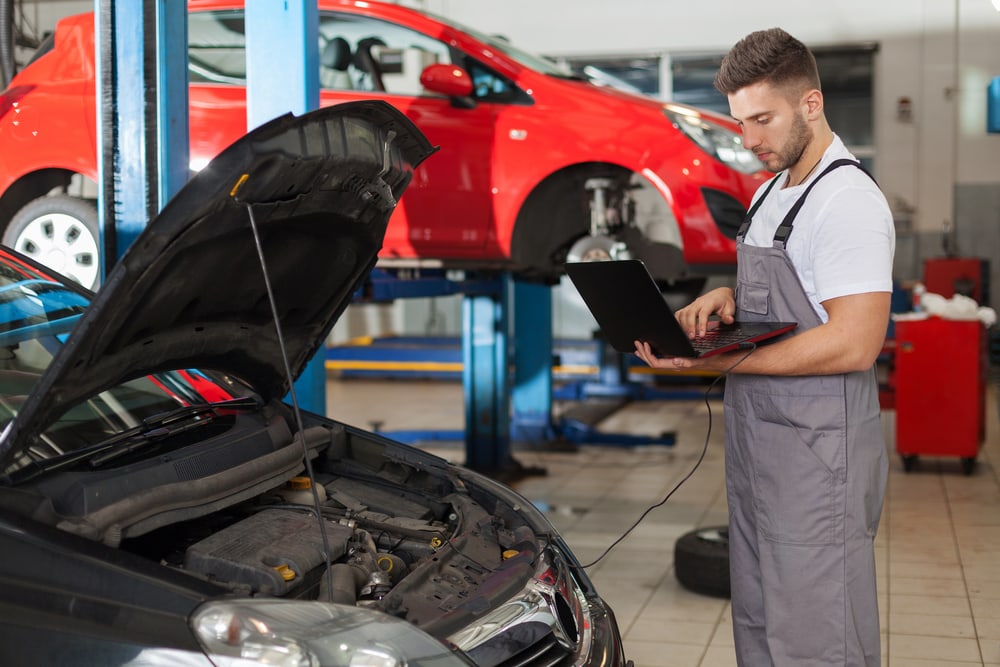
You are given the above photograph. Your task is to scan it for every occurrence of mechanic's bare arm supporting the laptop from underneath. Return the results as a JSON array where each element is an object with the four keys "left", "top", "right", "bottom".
[{"left": 636, "top": 292, "right": 892, "bottom": 375}]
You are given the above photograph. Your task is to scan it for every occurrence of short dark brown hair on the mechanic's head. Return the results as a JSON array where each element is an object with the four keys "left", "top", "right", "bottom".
[{"left": 715, "top": 28, "right": 820, "bottom": 95}]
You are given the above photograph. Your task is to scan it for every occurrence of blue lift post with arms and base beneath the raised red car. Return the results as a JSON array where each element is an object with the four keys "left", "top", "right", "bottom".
[{"left": 350, "top": 268, "right": 688, "bottom": 474}]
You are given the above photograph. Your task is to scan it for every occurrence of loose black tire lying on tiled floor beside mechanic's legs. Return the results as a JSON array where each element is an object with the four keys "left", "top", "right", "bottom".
[{"left": 674, "top": 526, "right": 730, "bottom": 598}]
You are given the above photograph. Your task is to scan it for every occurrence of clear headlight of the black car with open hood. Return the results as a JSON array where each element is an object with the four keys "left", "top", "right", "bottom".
[{"left": 191, "top": 600, "right": 471, "bottom": 667}]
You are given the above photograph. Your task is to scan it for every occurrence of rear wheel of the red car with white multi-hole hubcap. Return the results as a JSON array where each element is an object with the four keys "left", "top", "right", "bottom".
[{"left": 3, "top": 195, "right": 101, "bottom": 289}]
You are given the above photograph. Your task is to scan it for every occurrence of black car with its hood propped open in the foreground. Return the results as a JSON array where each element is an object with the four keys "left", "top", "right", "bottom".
[{"left": 0, "top": 102, "right": 626, "bottom": 667}]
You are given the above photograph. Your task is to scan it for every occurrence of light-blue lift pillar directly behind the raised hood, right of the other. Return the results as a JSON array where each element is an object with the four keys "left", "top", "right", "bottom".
[{"left": 245, "top": 2, "right": 326, "bottom": 414}]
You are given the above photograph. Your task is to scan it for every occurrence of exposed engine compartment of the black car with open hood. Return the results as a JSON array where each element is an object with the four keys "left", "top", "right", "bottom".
[{"left": 106, "top": 418, "right": 540, "bottom": 633}]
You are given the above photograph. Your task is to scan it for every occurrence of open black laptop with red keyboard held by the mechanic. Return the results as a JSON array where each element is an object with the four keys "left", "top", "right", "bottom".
[{"left": 566, "top": 259, "right": 796, "bottom": 357}]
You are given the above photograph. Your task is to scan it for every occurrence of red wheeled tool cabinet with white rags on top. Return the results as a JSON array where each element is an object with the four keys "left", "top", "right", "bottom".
[{"left": 894, "top": 317, "right": 987, "bottom": 474}]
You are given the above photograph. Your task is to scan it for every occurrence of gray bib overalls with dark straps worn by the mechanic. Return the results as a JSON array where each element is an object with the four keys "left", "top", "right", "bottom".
[{"left": 725, "top": 160, "right": 888, "bottom": 667}]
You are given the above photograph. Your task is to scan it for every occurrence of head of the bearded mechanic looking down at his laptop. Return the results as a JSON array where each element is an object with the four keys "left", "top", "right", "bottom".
[{"left": 715, "top": 28, "right": 832, "bottom": 176}]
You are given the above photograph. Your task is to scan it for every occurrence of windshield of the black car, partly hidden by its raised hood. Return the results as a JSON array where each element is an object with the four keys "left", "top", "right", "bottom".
[{"left": 0, "top": 251, "right": 232, "bottom": 473}]
